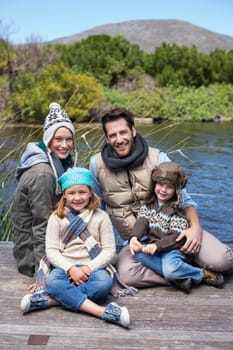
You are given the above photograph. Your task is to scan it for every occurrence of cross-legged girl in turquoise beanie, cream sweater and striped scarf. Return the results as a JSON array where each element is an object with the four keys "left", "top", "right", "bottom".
[{"left": 21, "top": 167, "right": 130, "bottom": 327}]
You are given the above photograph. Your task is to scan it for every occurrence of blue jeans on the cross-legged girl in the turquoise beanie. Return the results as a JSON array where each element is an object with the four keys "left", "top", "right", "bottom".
[{"left": 46, "top": 265, "right": 112, "bottom": 311}]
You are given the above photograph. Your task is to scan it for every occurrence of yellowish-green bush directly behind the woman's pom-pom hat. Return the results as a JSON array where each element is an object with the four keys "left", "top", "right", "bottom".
[{"left": 12, "top": 64, "right": 101, "bottom": 123}]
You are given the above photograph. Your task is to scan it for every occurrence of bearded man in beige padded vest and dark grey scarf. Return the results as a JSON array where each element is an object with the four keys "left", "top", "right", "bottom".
[{"left": 90, "top": 108, "right": 233, "bottom": 288}]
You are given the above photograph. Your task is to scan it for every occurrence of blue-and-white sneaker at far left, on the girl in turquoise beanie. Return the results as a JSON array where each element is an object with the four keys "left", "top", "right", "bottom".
[{"left": 20, "top": 291, "right": 49, "bottom": 313}]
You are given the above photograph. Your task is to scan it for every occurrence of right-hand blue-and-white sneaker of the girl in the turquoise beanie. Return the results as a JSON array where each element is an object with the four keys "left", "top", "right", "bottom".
[{"left": 102, "top": 303, "right": 130, "bottom": 328}]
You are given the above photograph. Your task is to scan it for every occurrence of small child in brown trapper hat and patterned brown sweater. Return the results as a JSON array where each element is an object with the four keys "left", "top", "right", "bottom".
[{"left": 130, "top": 162, "right": 223, "bottom": 293}]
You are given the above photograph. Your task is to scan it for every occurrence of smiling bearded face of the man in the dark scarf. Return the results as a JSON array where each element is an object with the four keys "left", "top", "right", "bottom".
[{"left": 105, "top": 118, "right": 136, "bottom": 158}]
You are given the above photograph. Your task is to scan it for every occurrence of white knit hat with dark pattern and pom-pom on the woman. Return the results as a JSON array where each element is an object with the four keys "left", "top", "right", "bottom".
[{"left": 43, "top": 102, "right": 75, "bottom": 147}]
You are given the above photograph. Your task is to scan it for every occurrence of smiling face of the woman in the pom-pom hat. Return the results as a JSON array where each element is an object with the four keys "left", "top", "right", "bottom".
[{"left": 49, "top": 127, "right": 74, "bottom": 159}]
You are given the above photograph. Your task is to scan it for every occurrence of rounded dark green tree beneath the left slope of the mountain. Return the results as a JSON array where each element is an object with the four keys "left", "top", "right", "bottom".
[{"left": 57, "top": 34, "right": 144, "bottom": 86}]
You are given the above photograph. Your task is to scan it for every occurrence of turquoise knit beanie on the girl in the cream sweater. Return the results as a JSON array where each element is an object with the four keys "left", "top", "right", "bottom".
[{"left": 57, "top": 167, "right": 92, "bottom": 192}]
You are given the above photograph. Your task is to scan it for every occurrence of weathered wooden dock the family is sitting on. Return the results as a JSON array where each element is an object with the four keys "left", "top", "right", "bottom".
[{"left": 0, "top": 242, "right": 233, "bottom": 350}]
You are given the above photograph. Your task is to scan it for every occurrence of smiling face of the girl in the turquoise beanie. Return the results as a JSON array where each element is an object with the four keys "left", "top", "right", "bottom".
[{"left": 63, "top": 185, "right": 92, "bottom": 211}]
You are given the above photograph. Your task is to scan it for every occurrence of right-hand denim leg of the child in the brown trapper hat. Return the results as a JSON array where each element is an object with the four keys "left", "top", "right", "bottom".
[{"left": 161, "top": 250, "right": 202, "bottom": 284}]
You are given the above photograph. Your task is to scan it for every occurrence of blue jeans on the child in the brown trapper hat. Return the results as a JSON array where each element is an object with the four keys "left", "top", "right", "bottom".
[{"left": 135, "top": 250, "right": 202, "bottom": 284}]
